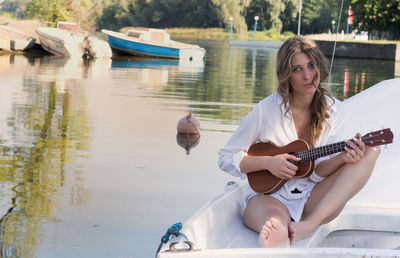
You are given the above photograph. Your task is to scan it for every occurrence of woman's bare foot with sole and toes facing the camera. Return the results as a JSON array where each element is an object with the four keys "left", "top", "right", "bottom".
[{"left": 258, "top": 218, "right": 290, "bottom": 247}]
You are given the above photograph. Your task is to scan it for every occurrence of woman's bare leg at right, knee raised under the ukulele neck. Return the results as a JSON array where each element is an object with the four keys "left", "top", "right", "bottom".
[{"left": 290, "top": 148, "right": 380, "bottom": 242}]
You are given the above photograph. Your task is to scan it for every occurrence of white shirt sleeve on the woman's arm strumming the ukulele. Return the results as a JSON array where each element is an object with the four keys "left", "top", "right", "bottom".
[{"left": 218, "top": 105, "right": 262, "bottom": 179}]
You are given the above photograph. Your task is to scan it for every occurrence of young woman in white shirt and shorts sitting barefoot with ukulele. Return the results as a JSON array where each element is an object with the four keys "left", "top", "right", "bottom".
[{"left": 219, "top": 36, "right": 380, "bottom": 247}]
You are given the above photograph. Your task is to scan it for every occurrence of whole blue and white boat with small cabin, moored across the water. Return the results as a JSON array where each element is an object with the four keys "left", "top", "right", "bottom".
[{"left": 101, "top": 28, "right": 205, "bottom": 61}]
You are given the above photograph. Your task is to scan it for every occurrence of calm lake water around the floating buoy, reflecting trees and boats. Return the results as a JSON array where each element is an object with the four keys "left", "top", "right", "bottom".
[{"left": 0, "top": 40, "right": 399, "bottom": 257}]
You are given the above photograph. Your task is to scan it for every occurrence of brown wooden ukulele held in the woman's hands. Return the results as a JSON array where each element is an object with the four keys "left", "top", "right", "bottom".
[{"left": 247, "top": 128, "right": 393, "bottom": 194}]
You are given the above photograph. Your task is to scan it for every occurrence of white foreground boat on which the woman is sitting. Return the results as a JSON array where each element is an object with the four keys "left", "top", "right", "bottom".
[{"left": 158, "top": 79, "right": 400, "bottom": 258}]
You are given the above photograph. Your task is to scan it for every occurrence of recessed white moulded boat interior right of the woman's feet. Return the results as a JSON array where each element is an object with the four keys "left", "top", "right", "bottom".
[{"left": 292, "top": 207, "right": 400, "bottom": 250}]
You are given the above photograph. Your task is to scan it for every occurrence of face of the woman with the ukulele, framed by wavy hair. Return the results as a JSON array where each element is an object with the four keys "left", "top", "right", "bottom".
[{"left": 289, "top": 52, "right": 319, "bottom": 96}]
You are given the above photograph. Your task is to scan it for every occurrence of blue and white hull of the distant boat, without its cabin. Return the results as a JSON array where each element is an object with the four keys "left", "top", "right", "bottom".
[{"left": 102, "top": 30, "right": 205, "bottom": 60}]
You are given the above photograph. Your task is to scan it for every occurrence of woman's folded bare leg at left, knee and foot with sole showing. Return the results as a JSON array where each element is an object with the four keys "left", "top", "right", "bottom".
[{"left": 243, "top": 195, "right": 290, "bottom": 247}]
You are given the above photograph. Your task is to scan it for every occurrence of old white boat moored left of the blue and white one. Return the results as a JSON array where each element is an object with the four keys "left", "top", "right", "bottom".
[{"left": 36, "top": 22, "right": 112, "bottom": 58}]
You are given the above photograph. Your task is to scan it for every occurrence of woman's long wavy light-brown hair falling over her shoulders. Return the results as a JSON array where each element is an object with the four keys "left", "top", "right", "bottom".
[{"left": 277, "top": 36, "right": 334, "bottom": 145}]
